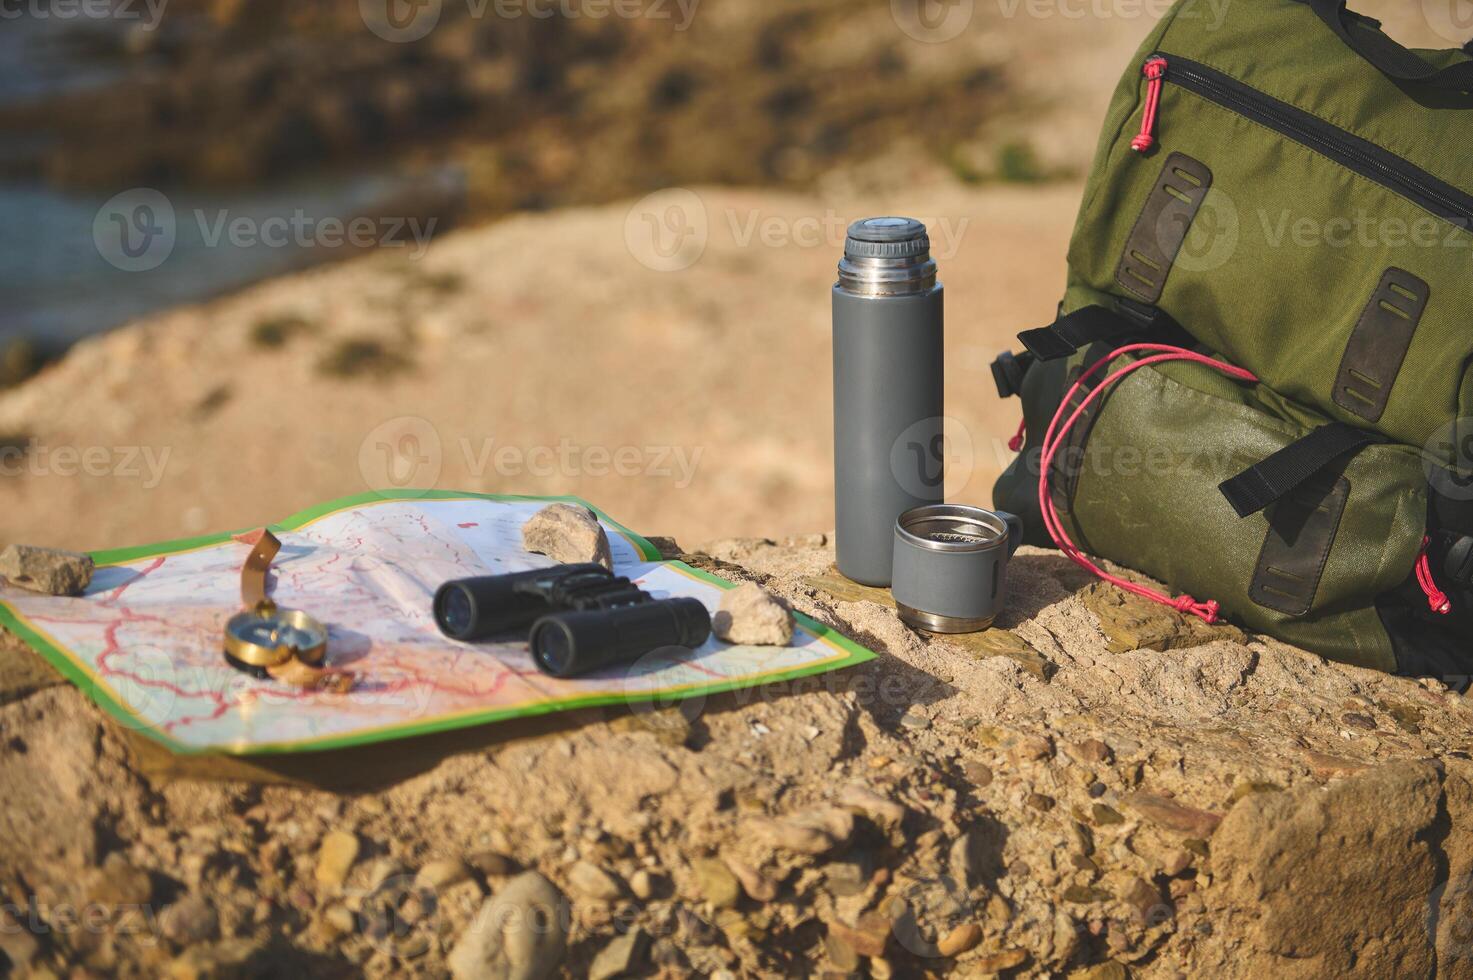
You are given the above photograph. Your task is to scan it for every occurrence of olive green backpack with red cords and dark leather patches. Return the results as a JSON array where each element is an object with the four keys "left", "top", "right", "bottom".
[{"left": 993, "top": 0, "right": 1473, "bottom": 678}]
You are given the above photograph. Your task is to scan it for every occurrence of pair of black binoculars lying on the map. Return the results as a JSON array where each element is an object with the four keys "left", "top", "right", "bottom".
[{"left": 435, "top": 563, "right": 711, "bottom": 678}]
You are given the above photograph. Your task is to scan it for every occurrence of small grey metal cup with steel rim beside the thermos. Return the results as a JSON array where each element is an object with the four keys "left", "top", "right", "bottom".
[{"left": 890, "top": 504, "right": 1022, "bottom": 632}]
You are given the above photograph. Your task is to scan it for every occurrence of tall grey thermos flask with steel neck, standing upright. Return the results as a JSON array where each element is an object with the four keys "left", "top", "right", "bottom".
[{"left": 834, "top": 218, "right": 944, "bottom": 585}]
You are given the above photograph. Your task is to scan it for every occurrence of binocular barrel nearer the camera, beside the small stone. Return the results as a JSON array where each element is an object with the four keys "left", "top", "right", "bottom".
[{"left": 527, "top": 598, "right": 711, "bottom": 678}]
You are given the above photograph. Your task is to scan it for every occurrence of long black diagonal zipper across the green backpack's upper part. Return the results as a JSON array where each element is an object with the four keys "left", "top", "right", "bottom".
[{"left": 1146, "top": 53, "right": 1473, "bottom": 228}]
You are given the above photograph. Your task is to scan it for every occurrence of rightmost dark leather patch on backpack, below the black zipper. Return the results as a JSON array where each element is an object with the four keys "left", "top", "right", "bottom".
[{"left": 1335, "top": 267, "right": 1432, "bottom": 421}]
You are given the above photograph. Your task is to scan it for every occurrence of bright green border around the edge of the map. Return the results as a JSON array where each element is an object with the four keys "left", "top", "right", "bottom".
[{"left": 0, "top": 489, "right": 875, "bottom": 757}]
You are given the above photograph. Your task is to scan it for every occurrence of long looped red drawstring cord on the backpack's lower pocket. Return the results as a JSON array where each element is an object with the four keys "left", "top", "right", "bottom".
[{"left": 1038, "top": 343, "right": 1258, "bottom": 623}]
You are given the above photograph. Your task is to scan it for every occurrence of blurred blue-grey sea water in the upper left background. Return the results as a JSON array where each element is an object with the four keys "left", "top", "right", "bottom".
[{"left": 0, "top": 16, "right": 460, "bottom": 349}]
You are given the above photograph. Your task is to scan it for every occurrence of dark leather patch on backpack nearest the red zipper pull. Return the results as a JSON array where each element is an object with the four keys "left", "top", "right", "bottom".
[{"left": 1115, "top": 153, "right": 1212, "bottom": 304}]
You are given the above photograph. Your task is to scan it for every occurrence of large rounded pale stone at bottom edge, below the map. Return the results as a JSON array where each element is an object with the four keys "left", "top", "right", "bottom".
[{"left": 446, "top": 871, "right": 572, "bottom": 980}]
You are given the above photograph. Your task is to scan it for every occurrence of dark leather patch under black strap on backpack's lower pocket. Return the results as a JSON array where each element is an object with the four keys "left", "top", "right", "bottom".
[{"left": 1248, "top": 476, "right": 1351, "bottom": 616}]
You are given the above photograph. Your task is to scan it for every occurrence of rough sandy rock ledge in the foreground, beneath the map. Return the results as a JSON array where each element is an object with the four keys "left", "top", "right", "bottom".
[{"left": 0, "top": 535, "right": 1473, "bottom": 980}]
